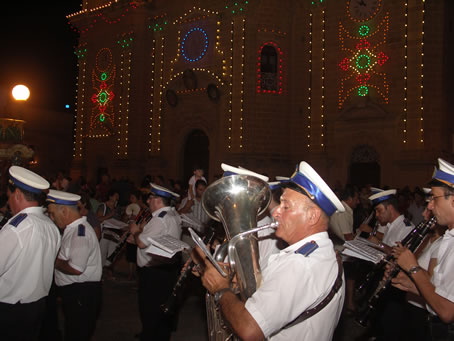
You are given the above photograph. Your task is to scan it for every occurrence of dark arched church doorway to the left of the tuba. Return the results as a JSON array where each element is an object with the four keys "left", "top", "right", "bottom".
[{"left": 183, "top": 129, "right": 210, "bottom": 184}]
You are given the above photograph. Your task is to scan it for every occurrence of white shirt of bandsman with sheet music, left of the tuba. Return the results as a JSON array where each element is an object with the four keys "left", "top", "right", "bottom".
[{"left": 137, "top": 206, "right": 181, "bottom": 267}]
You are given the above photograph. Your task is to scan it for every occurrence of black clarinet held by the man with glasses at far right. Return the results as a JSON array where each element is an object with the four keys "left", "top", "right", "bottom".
[{"left": 356, "top": 217, "right": 436, "bottom": 327}]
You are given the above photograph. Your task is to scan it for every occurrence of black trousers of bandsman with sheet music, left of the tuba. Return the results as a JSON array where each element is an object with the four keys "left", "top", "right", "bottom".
[{"left": 138, "top": 265, "right": 178, "bottom": 341}]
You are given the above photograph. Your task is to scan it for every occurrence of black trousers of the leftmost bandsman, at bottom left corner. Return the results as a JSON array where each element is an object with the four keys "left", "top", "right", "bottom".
[{"left": 0, "top": 297, "right": 46, "bottom": 341}]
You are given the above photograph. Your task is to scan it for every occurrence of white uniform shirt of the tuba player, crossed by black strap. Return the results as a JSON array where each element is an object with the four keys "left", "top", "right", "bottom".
[{"left": 246, "top": 232, "right": 345, "bottom": 341}]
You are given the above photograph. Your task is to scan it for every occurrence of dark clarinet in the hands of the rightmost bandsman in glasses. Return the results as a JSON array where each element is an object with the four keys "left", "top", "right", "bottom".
[{"left": 356, "top": 217, "right": 436, "bottom": 327}]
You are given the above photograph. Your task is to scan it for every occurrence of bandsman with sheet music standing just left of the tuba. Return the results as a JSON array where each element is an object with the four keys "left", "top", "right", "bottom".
[{"left": 130, "top": 184, "right": 181, "bottom": 340}]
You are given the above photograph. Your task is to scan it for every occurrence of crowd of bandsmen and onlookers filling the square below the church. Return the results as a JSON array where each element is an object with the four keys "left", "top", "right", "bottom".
[{"left": 0, "top": 159, "right": 454, "bottom": 341}]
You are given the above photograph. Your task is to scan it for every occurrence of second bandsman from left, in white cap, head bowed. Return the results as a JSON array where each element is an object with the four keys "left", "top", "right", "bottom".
[{"left": 46, "top": 189, "right": 102, "bottom": 341}]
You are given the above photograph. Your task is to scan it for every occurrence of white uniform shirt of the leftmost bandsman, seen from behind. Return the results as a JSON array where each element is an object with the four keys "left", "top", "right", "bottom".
[{"left": 0, "top": 207, "right": 60, "bottom": 304}]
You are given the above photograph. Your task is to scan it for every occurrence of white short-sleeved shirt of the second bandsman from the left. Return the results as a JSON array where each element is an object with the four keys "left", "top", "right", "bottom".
[{"left": 55, "top": 216, "right": 102, "bottom": 286}]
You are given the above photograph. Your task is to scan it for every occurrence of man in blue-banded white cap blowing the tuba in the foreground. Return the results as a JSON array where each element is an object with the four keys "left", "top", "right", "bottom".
[{"left": 194, "top": 161, "right": 344, "bottom": 340}]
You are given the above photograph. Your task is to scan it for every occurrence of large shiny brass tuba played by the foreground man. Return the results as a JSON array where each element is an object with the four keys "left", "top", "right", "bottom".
[{"left": 202, "top": 175, "right": 275, "bottom": 341}]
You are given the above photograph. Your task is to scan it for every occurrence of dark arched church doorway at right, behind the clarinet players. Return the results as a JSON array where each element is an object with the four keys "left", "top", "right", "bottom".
[{"left": 348, "top": 145, "right": 380, "bottom": 188}]
